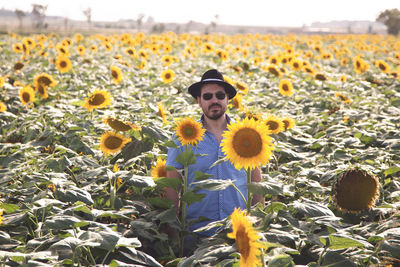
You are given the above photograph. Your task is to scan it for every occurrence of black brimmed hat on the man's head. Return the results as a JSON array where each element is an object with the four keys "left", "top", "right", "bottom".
[{"left": 188, "top": 69, "right": 236, "bottom": 99}]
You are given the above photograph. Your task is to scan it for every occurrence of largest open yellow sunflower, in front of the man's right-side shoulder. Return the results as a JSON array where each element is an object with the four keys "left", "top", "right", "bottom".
[{"left": 222, "top": 118, "right": 274, "bottom": 169}]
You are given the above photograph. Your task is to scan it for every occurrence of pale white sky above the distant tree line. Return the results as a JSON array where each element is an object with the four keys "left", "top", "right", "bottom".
[{"left": 0, "top": 0, "right": 400, "bottom": 27}]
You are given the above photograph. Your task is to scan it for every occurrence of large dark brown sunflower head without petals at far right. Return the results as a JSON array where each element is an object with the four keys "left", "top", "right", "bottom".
[{"left": 333, "top": 169, "right": 379, "bottom": 213}]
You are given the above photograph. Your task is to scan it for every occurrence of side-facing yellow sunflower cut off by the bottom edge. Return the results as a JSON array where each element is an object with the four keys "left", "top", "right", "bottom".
[{"left": 227, "top": 208, "right": 264, "bottom": 267}]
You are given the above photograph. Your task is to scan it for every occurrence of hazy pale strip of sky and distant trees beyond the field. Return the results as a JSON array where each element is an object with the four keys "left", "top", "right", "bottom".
[{"left": 0, "top": 0, "right": 400, "bottom": 34}]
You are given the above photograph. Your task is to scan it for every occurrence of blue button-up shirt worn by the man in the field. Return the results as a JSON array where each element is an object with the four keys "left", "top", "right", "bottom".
[{"left": 166, "top": 115, "right": 247, "bottom": 236}]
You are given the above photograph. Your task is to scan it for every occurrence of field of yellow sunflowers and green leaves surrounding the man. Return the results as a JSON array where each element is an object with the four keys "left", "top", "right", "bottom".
[{"left": 0, "top": 32, "right": 400, "bottom": 267}]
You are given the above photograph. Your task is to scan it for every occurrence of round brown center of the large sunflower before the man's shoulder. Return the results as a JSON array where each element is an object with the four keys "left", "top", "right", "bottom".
[{"left": 232, "top": 128, "right": 262, "bottom": 158}]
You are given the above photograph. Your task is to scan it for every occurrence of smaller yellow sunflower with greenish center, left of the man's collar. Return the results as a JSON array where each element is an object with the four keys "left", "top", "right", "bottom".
[{"left": 175, "top": 118, "right": 206, "bottom": 146}]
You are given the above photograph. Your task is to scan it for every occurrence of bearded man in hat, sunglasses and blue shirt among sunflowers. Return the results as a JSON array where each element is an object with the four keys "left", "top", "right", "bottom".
[{"left": 165, "top": 69, "right": 262, "bottom": 236}]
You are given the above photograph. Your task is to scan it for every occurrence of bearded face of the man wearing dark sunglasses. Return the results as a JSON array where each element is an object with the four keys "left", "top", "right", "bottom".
[{"left": 197, "top": 83, "right": 228, "bottom": 120}]
